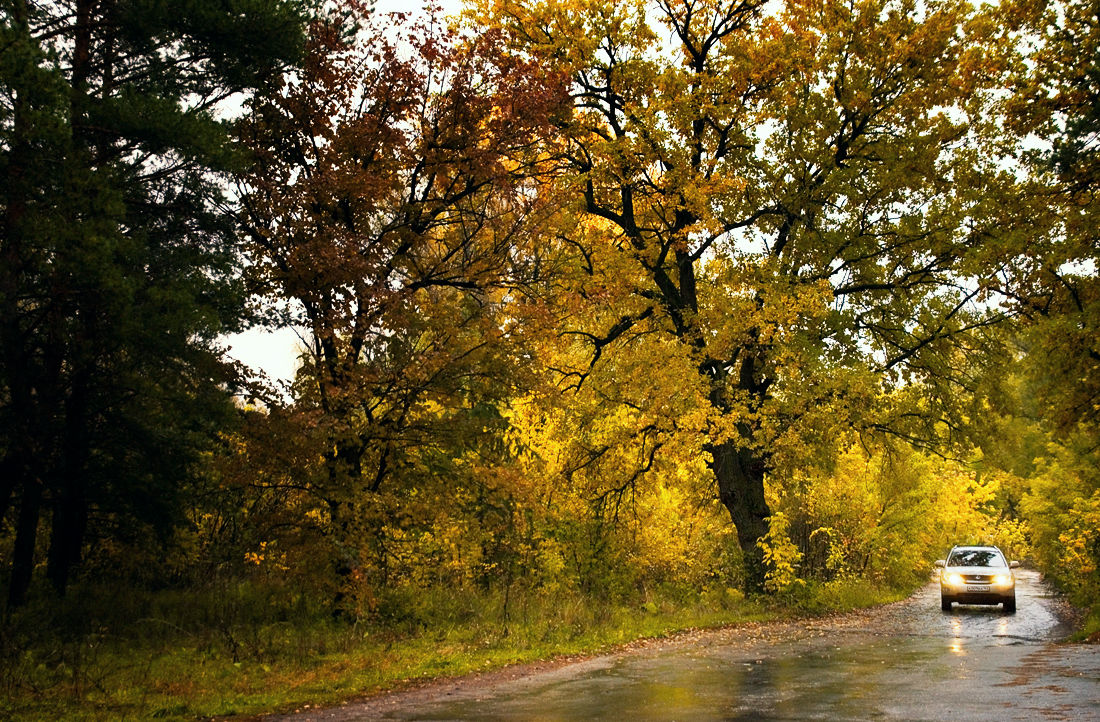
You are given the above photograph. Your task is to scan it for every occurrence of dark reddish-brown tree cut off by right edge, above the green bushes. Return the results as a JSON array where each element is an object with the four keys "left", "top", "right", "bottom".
[{"left": 1011, "top": 1, "right": 1100, "bottom": 436}]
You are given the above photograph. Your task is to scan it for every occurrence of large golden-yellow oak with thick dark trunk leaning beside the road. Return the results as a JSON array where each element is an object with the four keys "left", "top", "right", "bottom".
[{"left": 479, "top": 0, "right": 1019, "bottom": 588}]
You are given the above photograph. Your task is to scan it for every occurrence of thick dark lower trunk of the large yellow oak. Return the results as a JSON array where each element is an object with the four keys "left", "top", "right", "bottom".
[{"left": 707, "top": 441, "right": 771, "bottom": 592}]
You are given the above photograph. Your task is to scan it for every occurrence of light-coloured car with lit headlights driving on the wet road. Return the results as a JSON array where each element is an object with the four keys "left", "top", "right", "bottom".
[{"left": 936, "top": 546, "right": 1020, "bottom": 614}]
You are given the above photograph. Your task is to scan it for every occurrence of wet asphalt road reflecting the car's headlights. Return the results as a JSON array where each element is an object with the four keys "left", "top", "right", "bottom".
[{"left": 272, "top": 570, "right": 1100, "bottom": 722}]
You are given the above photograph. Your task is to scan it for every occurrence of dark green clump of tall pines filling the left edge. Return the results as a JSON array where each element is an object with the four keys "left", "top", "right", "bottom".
[{"left": 0, "top": 0, "right": 303, "bottom": 605}]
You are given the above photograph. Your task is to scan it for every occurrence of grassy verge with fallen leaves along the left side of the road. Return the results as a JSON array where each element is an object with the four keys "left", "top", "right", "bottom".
[{"left": 0, "top": 584, "right": 905, "bottom": 722}]
